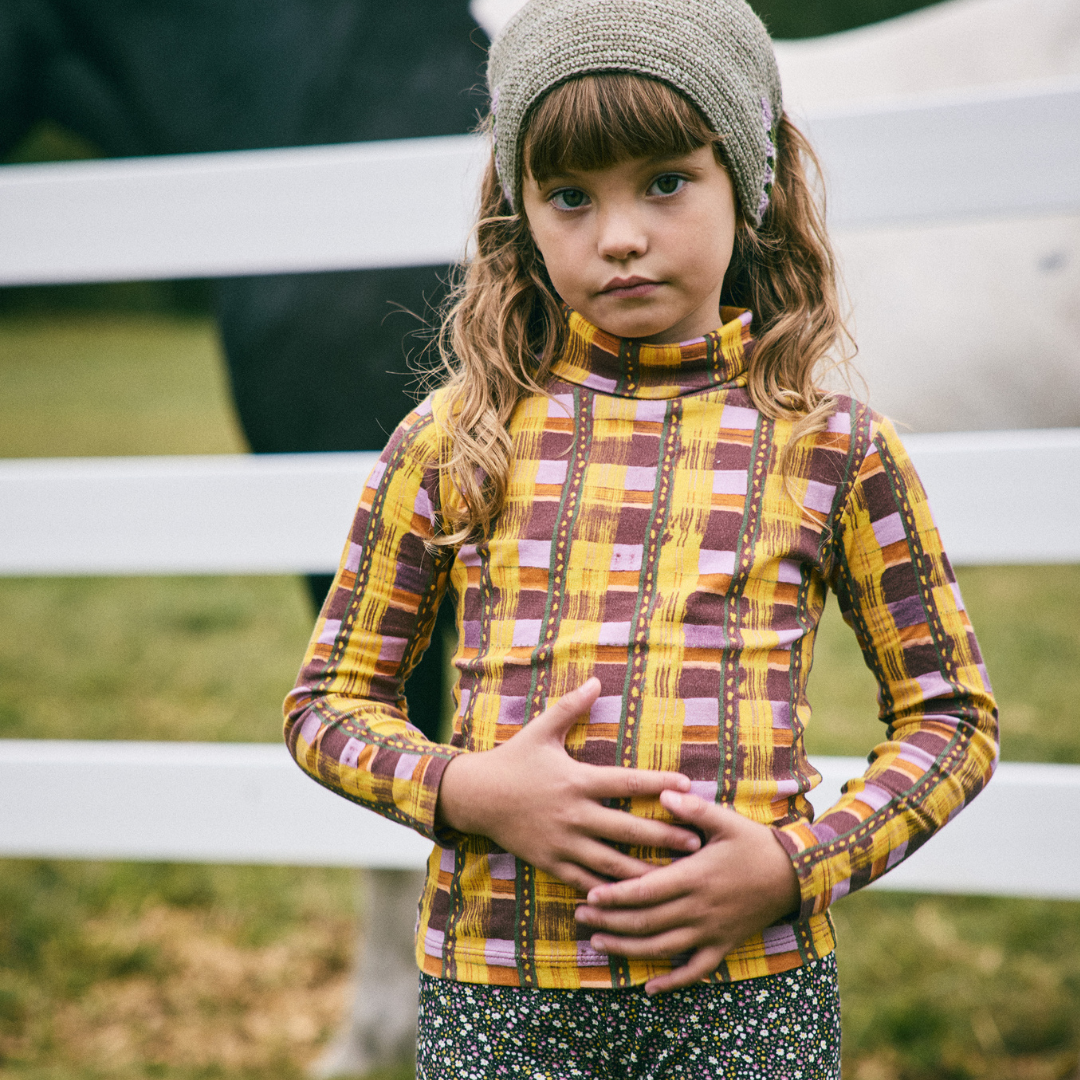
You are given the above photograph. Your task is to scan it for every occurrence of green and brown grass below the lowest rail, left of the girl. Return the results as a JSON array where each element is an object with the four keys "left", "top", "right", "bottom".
[{"left": 0, "top": 861, "right": 355, "bottom": 1078}]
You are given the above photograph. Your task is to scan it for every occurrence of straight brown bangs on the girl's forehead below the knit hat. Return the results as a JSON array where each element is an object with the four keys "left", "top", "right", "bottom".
[{"left": 522, "top": 71, "right": 719, "bottom": 184}]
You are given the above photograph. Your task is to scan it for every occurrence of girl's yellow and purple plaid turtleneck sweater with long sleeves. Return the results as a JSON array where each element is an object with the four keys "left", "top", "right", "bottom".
[{"left": 285, "top": 309, "right": 997, "bottom": 988}]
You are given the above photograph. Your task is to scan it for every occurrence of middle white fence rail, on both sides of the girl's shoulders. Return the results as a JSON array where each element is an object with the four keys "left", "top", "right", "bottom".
[{"left": 6, "top": 429, "right": 1080, "bottom": 575}]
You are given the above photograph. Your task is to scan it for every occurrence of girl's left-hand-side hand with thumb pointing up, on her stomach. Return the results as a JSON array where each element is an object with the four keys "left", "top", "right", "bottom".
[{"left": 436, "top": 678, "right": 701, "bottom": 893}]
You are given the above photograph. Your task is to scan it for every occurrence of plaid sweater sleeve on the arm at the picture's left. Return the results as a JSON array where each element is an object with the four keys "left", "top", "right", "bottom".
[{"left": 284, "top": 399, "right": 459, "bottom": 838}]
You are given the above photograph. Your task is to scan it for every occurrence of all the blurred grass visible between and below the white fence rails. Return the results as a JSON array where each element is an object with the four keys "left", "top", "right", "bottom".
[{"left": 0, "top": 314, "right": 1080, "bottom": 1080}]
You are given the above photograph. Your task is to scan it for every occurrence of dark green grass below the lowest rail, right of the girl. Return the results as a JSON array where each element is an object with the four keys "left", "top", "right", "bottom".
[{"left": 834, "top": 891, "right": 1080, "bottom": 1080}]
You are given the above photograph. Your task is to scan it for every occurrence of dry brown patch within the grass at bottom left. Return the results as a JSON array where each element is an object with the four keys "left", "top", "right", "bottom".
[{"left": 23, "top": 906, "right": 352, "bottom": 1071}]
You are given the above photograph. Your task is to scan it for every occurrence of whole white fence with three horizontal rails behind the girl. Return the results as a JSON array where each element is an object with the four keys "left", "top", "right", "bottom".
[{"left": 0, "top": 79, "right": 1080, "bottom": 899}]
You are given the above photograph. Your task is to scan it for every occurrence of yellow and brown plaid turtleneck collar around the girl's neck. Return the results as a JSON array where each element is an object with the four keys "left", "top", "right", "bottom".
[{"left": 551, "top": 308, "right": 754, "bottom": 400}]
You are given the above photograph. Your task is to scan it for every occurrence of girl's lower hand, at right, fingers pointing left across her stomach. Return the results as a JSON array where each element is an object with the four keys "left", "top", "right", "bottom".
[{"left": 577, "top": 791, "right": 800, "bottom": 994}]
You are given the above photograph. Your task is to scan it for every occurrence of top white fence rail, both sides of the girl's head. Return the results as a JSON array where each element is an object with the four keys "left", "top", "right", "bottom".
[{"left": 0, "top": 83, "right": 1080, "bottom": 285}]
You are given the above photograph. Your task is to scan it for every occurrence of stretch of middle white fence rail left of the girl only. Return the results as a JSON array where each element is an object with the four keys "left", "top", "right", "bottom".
[{"left": 0, "top": 454, "right": 378, "bottom": 575}]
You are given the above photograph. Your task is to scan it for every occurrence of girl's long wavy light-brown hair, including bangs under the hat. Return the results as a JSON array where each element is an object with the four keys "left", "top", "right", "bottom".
[{"left": 434, "top": 72, "right": 851, "bottom": 545}]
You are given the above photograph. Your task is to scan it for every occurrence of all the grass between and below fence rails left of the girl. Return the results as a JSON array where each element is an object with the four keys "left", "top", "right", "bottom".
[{"left": 0, "top": 313, "right": 356, "bottom": 1080}]
